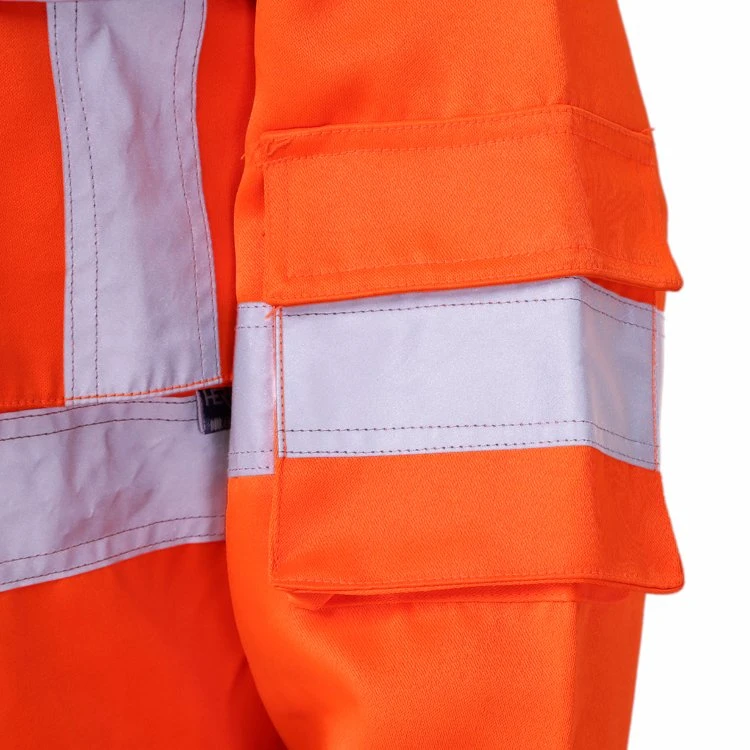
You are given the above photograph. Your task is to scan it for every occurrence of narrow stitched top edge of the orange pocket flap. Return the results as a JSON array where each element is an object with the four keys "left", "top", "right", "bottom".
[{"left": 263, "top": 105, "right": 654, "bottom": 148}]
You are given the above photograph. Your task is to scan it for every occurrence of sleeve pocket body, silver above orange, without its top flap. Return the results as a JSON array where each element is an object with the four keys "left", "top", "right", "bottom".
[{"left": 270, "top": 277, "right": 682, "bottom": 608}]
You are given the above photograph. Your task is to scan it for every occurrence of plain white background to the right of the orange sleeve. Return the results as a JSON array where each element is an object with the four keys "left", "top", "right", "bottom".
[{"left": 624, "top": 0, "right": 750, "bottom": 750}]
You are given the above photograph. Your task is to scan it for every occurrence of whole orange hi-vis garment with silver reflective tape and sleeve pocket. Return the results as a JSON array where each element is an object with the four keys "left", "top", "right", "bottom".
[{"left": 0, "top": 0, "right": 683, "bottom": 750}]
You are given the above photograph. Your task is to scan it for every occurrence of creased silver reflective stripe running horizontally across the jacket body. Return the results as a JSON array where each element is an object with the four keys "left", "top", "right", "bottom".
[{"left": 0, "top": 397, "right": 228, "bottom": 590}]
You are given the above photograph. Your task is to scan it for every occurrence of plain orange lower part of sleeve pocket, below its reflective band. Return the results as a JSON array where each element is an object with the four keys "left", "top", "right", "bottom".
[{"left": 270, "top": 446, "right": 682, "bottom": 593}]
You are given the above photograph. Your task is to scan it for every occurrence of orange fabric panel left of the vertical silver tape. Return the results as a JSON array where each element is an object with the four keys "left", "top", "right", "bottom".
[{"left": 0, "top": 3, "right": 65, "bottom": 411}]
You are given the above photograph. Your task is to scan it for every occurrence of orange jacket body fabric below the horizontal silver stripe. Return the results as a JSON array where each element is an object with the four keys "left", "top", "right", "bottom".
[{"left": 0, "top": 543, "right": 280, "bottom": 750}]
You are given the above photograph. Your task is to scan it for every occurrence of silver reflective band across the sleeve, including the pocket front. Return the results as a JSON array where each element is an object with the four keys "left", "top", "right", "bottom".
[{"left": 232, "top": 278, "right": 663, "bottom": 474}]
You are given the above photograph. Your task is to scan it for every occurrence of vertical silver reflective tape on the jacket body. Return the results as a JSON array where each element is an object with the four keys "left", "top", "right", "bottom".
[{"left": 47, "top": 0, "right": 221, "bottom": 400}]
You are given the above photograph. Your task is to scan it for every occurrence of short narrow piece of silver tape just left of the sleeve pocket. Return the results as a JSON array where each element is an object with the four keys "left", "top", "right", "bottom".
[{"left": 229, "top": 304, "right": 275, "bottom": 476}]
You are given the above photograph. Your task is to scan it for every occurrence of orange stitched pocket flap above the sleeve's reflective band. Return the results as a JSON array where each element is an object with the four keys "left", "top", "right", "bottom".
[{"left": 259, "top": 106, "right": 681, "bottom": 304}]
